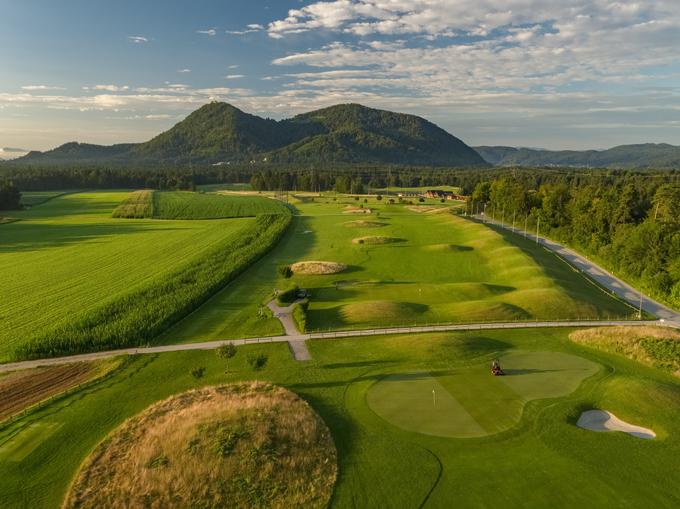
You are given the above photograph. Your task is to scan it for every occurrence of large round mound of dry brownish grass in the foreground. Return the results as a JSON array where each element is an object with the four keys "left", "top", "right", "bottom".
[{"left": 64, "top": 382, "right": 337, "bottom": 508}]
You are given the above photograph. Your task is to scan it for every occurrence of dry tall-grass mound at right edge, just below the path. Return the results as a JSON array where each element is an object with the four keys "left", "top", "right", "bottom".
[{"left": 569, "top": 326, "right": 680, "bottom": 376}]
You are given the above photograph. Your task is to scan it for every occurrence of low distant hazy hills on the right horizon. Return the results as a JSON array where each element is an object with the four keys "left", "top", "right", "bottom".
[{"left": 474, "top": 143, "right": 680, "bottom": 169}]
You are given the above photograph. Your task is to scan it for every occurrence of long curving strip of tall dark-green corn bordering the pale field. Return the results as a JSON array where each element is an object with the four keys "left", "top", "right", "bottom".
[{"left": 14, "top": 212, "right": 292, "bottom": 359}]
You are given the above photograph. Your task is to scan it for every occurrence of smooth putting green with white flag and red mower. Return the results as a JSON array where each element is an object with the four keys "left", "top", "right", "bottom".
[{"left": 366, "top": 351, "right": 599, "bottom": 438}]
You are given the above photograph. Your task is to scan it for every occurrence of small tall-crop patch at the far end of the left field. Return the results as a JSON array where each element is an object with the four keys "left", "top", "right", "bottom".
[{"left": 153, "top": 191, "right": 286, "bottom": 219}]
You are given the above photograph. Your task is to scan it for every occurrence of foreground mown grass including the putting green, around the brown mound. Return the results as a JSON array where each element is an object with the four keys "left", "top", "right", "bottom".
[{"left": 0, "top": 329, "right": 680, "bottom": 509}]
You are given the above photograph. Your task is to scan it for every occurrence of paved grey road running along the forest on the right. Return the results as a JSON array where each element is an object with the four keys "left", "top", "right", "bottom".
[{"left": 474, "top": 216, "right": 680, "bottom": 326}]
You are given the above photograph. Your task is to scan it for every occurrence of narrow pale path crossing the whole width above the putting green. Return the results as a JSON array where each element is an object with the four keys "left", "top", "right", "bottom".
[{"left": 0, "top": 320, "right": 668, "bottom": 372}]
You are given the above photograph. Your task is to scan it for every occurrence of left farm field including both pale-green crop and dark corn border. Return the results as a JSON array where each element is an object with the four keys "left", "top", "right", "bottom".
[{"left": 0, "top": 192, "right": 288, "bottom": 361}]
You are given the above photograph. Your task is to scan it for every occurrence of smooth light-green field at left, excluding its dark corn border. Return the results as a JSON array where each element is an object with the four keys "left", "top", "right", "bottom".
[{"left": 0, "top": 192, "right": 253, "bottom": 360}]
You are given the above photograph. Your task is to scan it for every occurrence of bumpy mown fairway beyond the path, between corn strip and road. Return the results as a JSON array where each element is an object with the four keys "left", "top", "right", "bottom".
[{"left": 164, "top": 197, "right": 631, "bottom": 342}]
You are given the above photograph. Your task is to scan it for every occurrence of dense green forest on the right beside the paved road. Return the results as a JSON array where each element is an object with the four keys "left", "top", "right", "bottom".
[{"left": 468, "top": 173, "right": 680, "bottom": 308}]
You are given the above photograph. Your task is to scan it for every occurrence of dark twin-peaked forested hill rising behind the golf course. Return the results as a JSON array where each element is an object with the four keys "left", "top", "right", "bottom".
[{"left": 14, "top": 102, "right": 488, "bottom": 167}]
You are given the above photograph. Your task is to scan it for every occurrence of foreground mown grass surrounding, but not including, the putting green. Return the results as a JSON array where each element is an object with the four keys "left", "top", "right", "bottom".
[{"left": 0, "top": 330, "right": 680, "bottom": 508}]
